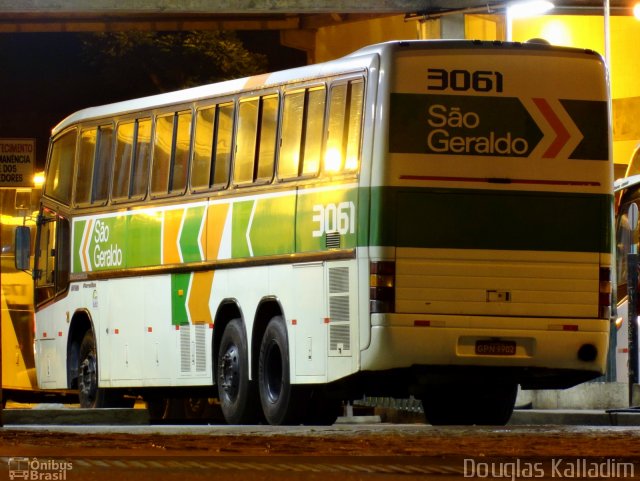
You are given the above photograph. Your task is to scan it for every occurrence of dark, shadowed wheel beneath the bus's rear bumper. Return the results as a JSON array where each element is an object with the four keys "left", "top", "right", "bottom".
[{"left": 422, "top": 384, "right": 518, "bottom": 426}]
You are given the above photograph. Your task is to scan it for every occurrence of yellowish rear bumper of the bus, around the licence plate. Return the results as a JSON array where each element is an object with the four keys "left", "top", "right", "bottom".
[{"left": 361, "top": 314, "right": 609, "bottom": 385}]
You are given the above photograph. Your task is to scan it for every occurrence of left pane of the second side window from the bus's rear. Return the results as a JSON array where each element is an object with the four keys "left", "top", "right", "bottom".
[{"left": 278, "top": 91, "right": 305, "bottom": 179}]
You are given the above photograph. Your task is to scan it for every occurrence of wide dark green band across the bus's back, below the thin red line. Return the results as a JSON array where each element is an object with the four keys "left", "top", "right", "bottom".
[{"left": 371, "top": 188, "right": 613, "bottom": 252}]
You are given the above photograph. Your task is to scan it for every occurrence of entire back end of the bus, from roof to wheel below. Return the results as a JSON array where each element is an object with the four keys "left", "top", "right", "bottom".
[{"left": 362, "top": 42, "right": 613, "bottom": 424}]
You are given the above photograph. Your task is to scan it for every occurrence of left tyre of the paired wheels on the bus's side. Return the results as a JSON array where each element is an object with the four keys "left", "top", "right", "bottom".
[{"left": 216, "top": 319, "right": 259, "bottom": 424}]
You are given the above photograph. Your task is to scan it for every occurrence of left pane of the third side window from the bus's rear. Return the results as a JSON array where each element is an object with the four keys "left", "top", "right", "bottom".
[{"left": 233, "top": 98, "right": 259, "bottom": 184}]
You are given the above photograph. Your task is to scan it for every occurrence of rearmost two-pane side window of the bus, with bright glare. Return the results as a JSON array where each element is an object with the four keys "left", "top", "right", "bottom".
[{"left": 323, "top": 80, "right": 364, "bottom": 174}]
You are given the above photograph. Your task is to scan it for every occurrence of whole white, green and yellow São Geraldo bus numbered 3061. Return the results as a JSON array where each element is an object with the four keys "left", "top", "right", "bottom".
[{"left": 16, "top": 41, "right": 613, "bottom": 425}]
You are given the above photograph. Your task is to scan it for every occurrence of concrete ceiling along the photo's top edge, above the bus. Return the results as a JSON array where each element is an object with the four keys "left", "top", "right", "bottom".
[{"left": 0, "top": 0, "right": 632, "bottom": 32}]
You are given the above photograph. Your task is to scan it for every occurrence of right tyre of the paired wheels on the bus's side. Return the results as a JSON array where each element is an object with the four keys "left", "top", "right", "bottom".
[{"left": 258, "top": 316, "right": 306, "bottom": 425}]
